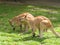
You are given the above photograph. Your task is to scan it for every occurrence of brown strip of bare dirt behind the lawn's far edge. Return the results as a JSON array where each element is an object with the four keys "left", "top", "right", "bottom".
[{"left": 0, "top": 0, "right": 60, "bottom": 7}]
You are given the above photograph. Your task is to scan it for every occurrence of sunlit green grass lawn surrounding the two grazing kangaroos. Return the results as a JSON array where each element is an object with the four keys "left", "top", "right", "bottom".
[{"left": 0, "top": 4, "right": 60, "bottom": 45}]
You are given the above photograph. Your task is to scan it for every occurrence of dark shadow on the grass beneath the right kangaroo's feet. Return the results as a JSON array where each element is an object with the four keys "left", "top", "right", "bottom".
[{"left": 20, "top": 36, "right": 58, "bottom": 44}]
